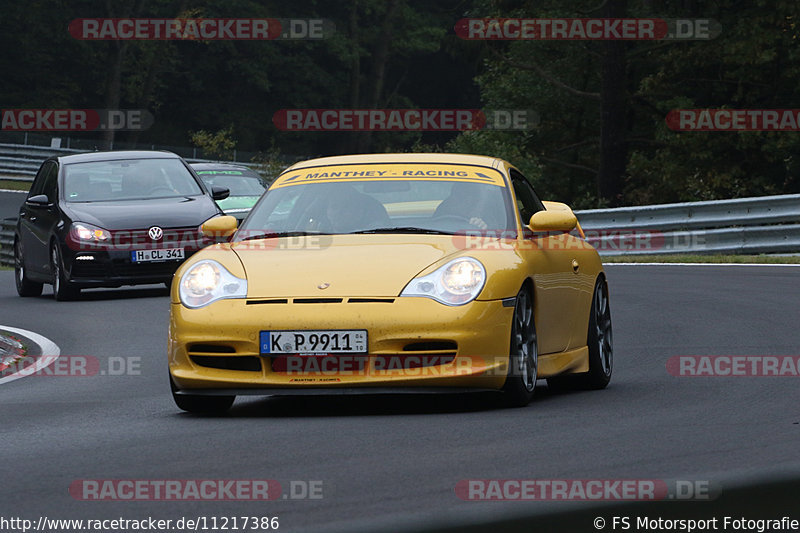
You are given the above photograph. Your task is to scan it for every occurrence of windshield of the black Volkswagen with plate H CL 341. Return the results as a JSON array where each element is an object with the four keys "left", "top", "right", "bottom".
[{"left": 64, "top": 159, "right": 203, "bottom": 202}]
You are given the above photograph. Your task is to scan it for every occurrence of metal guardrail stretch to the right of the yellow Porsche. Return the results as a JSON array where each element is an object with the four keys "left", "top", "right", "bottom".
[{"left": 575, "top": 194, "right": 800, "bottom": 255}]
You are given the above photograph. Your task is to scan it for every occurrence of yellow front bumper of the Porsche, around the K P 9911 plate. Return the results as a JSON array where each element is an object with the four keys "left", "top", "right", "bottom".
[{"left": 168, "top": 298, "right": 514, "bottom": 395}]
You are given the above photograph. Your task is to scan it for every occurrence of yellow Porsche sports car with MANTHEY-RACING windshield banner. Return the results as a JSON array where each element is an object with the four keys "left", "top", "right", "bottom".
[{"left": 169, "top": 154, "right": 613, "bottom": 412}]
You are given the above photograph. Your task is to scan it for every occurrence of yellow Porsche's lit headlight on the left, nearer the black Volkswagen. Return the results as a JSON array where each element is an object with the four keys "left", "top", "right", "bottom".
[{"left": 178, "top": 259, "right": 247, "bottom": 309}]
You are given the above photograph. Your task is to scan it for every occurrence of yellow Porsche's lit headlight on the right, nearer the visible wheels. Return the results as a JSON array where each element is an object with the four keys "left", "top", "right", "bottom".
[{"left": 400, "top": 257, "right": 486, "bottom": 305}]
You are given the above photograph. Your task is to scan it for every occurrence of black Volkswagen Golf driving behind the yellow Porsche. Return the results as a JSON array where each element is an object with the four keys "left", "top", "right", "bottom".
[{"left": 14, "top": 151, "right": 229, "bottom": 300}]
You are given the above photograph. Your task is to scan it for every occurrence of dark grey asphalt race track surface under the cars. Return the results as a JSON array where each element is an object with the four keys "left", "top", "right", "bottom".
[{"left": 0, "top": 264, "right": 800, "bottom": 531}]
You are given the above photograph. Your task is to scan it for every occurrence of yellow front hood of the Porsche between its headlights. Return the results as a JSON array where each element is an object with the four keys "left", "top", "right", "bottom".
[{"left": 231, "top": 234, "right": 459, "bottom": 298}]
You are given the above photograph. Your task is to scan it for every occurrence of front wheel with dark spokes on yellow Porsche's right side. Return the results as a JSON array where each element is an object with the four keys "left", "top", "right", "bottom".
[{"left": 503, "top": 287, "right": 539, "bottom": 407}]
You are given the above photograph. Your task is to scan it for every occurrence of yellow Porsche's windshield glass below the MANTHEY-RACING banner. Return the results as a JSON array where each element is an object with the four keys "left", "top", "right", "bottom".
[{"left": 237, "top": 180, "right": 515, "bottom": 239}]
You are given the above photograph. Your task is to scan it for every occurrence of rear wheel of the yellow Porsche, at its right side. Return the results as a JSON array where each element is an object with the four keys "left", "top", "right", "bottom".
[{"left": 547, "top": 278, "right": 614, "bottom": 391}]
